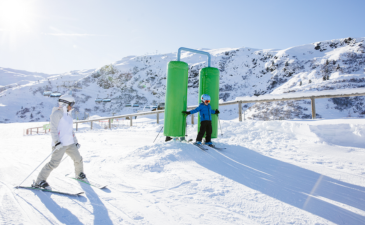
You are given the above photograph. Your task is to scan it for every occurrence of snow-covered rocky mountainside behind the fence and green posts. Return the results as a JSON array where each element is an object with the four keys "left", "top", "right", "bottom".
[{"left": 0, "top": 38, "right": 365, "bottom": 122}]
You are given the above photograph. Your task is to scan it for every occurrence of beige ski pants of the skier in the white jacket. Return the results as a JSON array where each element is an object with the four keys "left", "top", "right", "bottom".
[{"left": 36, "top": 144, "right": 84, "bottom": 183}]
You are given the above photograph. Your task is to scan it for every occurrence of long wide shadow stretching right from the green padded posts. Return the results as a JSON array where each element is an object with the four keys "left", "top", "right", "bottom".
[{"left": 183, "top": 145, "right": 365, "bottom": 224}]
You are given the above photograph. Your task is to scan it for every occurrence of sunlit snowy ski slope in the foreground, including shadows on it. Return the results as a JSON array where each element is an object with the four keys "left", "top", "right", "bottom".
[{"left": 0, "top": 118, "right": 365, "bottom": 225}]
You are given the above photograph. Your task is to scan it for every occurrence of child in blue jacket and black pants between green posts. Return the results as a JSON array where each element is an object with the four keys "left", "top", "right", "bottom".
[{"left": 182, "top": 94, "right": 219, "bottom": 146}]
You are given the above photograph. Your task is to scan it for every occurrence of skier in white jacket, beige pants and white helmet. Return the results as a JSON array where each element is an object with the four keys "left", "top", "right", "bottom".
[{"left": 32, "top": 95, "right": 86, "bottom": 190}]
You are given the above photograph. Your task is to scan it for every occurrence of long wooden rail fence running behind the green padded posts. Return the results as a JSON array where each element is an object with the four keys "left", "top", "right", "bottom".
[{"left": 22, "top": 89, "right": 365, "bottom": 135}]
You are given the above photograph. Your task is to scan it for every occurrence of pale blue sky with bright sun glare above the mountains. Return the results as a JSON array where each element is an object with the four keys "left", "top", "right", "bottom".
[{"left": 0, "top": 0, "right": 365, "bottom": 73}]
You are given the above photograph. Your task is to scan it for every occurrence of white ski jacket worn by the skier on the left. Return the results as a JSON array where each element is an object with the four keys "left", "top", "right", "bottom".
[{"left": 50, "top": 107, "right": 78, "bottom": 146}]
